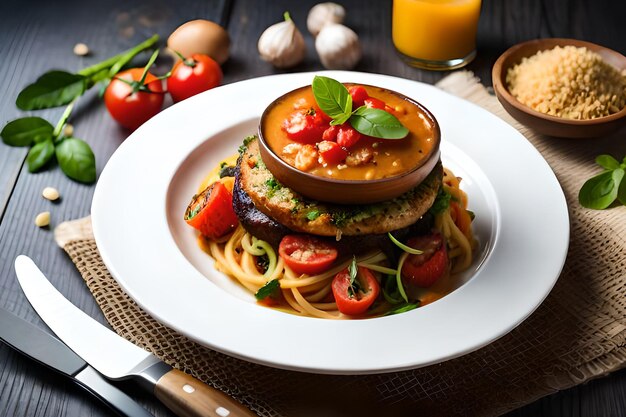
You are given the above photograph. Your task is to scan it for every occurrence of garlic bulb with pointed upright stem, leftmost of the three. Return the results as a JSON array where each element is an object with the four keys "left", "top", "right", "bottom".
[{"left": 257, "top": 12, "right": 306, "bottom": 68}]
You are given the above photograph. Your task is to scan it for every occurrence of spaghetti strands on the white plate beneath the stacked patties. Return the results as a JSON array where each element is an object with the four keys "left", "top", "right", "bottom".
[{"left": 193, "top": 158, "right": 476, "bottom": 319}]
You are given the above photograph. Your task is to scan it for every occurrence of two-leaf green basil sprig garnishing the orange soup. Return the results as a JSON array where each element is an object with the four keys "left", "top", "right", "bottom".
[{"left": 311, "top": 75, "right": 409, "bottom": 139}]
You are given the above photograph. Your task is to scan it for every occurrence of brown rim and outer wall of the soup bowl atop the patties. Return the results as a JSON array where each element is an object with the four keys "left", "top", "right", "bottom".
[{"left": 259, "top": 84, "right": 441, "bottom": 204}]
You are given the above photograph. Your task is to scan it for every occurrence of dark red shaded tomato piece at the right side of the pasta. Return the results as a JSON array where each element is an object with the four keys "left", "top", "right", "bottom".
[{"left": 401, "top": 233, "right": 448, "bottom": 288}]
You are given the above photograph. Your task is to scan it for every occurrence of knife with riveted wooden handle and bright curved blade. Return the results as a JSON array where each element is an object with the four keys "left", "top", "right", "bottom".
[{"left": 15, "top": 255, "right": 256, "bottom": 417}]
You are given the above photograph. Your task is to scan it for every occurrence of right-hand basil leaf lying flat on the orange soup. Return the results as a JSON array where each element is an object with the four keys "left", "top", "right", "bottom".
[{"left": 350, "top": 106, "right": 409, "bottom": 139}]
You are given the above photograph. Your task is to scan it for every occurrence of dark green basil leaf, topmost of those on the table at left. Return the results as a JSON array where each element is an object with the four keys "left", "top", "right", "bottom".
[{"left": 15, "top": 71, "right": 87, "bottom": 110}]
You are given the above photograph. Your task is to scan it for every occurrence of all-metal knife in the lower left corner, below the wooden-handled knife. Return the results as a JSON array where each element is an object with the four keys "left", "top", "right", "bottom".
[{"left": 0, "top": 308, "right": 152, "bottom": 417}]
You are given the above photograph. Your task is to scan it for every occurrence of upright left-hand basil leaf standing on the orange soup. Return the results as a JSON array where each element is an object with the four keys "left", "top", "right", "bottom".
[{"left": 311, "top": 75, "right": 352, "bottom": 120}]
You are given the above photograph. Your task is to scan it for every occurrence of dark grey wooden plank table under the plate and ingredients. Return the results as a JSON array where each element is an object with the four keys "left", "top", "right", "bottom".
[{"left": 0, "top": 0, "right": 626, "bottom": 417}]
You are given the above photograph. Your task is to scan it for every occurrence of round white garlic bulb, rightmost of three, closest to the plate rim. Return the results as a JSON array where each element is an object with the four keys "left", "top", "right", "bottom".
[{"left": 315, "top": 23, "right": 361, "bottom": 70}]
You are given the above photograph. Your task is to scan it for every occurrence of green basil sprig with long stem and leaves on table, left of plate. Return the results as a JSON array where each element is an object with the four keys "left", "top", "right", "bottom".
[{"left": 0, "top": 35, "right": 159, "bottom": 183}]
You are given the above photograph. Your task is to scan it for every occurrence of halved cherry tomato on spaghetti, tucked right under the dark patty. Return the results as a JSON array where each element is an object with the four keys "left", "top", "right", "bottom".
[{"left": 278, "top": 235, "right": 337, "bottom": 275}]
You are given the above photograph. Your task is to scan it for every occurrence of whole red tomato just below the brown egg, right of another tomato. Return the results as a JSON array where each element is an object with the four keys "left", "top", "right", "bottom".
[{"left": 167, "top": 54, "right": 223, "bottom": 101}]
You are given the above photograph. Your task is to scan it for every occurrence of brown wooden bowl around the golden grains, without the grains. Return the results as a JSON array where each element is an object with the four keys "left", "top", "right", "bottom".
[{"left": 491, "top": 38, "right": 626, "bottom": 138}]
